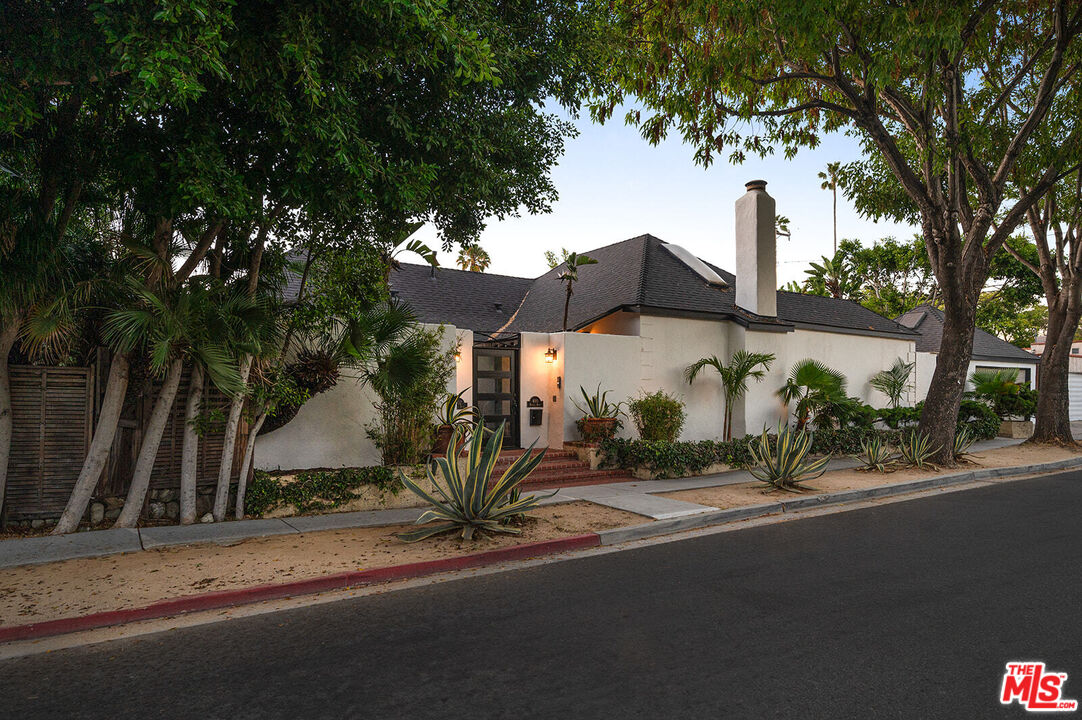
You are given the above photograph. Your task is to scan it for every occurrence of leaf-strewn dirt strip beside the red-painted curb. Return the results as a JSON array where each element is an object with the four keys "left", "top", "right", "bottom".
[{"left": 0, "top": 502, "right": 649, "bottom": 625}]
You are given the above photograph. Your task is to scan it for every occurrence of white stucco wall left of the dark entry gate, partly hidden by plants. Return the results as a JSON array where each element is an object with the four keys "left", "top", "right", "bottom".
[{"left": 254, "top": 325, "right": 460, "bottom": 470}]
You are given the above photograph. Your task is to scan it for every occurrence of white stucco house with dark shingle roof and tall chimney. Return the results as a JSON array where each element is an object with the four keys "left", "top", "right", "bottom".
[{"left": 255, "top": 181, "right": 1038, "bottom": 469}]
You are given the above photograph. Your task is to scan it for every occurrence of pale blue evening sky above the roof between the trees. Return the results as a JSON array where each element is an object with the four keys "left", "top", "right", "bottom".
[{"left": 413, "top": 109, "right": 919, "bottom": 286}]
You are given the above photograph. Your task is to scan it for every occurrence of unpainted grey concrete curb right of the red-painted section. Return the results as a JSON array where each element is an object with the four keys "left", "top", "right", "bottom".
[{"left": 597, "top": 458, "right": 1082, "bottom": 545}]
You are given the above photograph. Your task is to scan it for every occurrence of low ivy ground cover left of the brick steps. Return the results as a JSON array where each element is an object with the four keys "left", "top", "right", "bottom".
[{"left": 245, "top": 466, "right": 403, "bottom": 516}]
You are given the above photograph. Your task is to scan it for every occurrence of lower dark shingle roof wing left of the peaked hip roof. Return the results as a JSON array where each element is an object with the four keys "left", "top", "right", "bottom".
[{"left": 391, "top": 263, "right": 533, "bottom": 331}]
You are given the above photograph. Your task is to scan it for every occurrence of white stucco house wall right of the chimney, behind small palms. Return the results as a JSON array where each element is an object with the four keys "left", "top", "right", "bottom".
[{"left": 734, "top": 328, "right": 916, "bottom": 435}]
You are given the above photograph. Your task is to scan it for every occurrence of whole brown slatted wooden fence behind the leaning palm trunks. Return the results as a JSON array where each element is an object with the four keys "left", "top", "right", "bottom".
[{"left": 4, "top": 358, "right": 248, "bottom": 519}]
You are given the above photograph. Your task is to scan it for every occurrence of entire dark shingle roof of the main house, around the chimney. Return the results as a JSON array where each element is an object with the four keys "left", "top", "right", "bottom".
[{"left": 391, "top": 235, "right": 914, "bottom": 337}]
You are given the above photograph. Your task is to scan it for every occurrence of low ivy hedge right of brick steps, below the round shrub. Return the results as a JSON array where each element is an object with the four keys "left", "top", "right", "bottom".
[{"left": 598, "top": 435, "right": 754, "bottom": 477}]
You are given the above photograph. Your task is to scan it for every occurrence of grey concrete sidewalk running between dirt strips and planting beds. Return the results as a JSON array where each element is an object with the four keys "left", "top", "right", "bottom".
[{"left": 0, "top": 438, "right": 1022, "bottom": 568}]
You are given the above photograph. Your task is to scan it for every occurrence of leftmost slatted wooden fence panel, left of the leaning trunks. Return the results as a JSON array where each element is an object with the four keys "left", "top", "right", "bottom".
[{"left": 4, "top": 365, "right": 94, "bottom": 518}]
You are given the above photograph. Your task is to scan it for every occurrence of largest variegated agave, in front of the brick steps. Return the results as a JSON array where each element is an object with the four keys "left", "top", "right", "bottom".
[{"left": 398, "top": 422, "right": 550, "bottom": 542}]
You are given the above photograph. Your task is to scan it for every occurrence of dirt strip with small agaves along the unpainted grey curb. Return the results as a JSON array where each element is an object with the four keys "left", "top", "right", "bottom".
[{"left": 662, "top": 445, "right": 1082, "bottom": 510}]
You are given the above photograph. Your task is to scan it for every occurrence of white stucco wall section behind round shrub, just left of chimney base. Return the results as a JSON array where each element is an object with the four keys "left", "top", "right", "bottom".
[{"left": 639, "top": 315, "right": 731, "bottom": 441}]
